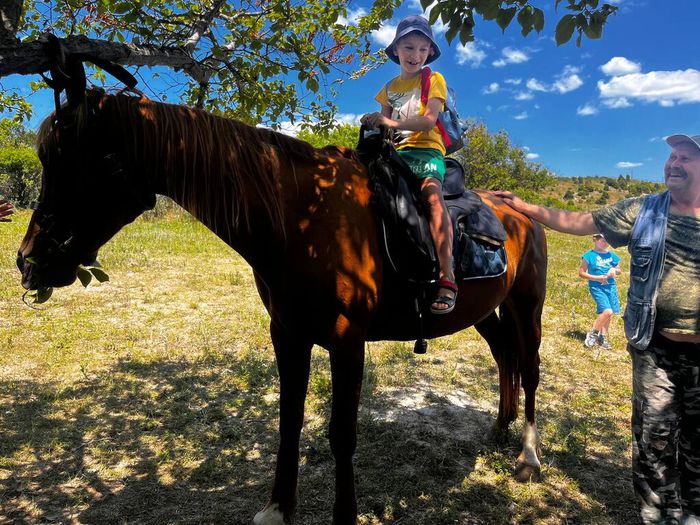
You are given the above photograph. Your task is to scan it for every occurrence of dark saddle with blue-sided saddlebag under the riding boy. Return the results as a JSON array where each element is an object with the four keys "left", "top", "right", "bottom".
[{"left": 356, "top": 127, "right": 506, "bottom": 284}]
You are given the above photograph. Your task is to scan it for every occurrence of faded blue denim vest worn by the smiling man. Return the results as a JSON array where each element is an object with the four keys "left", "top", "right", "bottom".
[{"left": 623, "top": 191, "right": 671, "bottom": 350}]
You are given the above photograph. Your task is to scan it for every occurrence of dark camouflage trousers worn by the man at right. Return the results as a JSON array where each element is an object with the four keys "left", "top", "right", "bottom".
[{"left": 628, "top": 335, "right": 700, "bottom": 525}]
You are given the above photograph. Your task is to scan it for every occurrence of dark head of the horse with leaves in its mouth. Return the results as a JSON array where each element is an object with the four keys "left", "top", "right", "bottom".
[{"left": 17, "top": 92, "right": 155, "bottom": 290}]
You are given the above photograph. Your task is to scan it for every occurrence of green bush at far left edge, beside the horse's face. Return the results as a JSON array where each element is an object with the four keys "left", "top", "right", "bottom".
[{"left": 0, "top": 119, "right": 41, "bottom": 207}]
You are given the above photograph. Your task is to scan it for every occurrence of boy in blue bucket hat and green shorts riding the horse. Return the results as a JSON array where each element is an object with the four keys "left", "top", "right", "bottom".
[{"left": 362, "top": 16, "right": 457, "bottom": 314}]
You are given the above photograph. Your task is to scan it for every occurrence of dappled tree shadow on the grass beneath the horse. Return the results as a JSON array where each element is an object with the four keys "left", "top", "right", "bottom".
[{"left": 0, "top": 350, "right": 633, "bottom": 525}]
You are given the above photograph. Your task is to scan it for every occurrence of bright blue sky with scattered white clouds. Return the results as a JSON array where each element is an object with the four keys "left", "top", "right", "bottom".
[{"left": 336, "top": 0, "right": 700, "bottom": 180}]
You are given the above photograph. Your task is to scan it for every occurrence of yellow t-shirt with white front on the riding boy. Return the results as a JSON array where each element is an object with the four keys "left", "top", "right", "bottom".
[{"left": 374, "top": 71, "right": 447, "bottom": 155}]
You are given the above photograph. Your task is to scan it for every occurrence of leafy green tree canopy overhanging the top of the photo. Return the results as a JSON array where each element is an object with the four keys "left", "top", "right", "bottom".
[{"left": 0, "top": 0, "right": 616, "bottom": 126}]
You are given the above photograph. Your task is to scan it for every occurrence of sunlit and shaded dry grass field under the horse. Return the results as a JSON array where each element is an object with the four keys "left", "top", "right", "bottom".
[{"left": 0, "top": 207, "right": 637, "bottom": 525}]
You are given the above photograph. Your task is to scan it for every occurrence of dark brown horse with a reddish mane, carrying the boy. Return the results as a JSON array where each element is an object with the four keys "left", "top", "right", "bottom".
[{"left": 17, "top": 91, "right": 547, "bottom": 525}]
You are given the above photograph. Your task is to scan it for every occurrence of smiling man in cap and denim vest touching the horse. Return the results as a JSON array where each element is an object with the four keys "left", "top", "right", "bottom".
[{"left": 493, "top": 135, "right": 700, "bottom": 525}]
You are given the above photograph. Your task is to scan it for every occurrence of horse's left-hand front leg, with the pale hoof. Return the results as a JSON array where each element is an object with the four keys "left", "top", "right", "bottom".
[{"left": 253, "top": 323, "right": 313, "bottom": 525}]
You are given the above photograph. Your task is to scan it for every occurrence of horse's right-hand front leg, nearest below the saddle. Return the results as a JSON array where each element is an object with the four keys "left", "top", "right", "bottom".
[{"left": 330, "top": 340, "right": 365, "bottom": 525}]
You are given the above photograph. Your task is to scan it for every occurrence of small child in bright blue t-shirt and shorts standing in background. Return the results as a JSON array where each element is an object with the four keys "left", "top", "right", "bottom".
[{"left": 578, "top": 233, "right": 621, "bottom": 350}]
